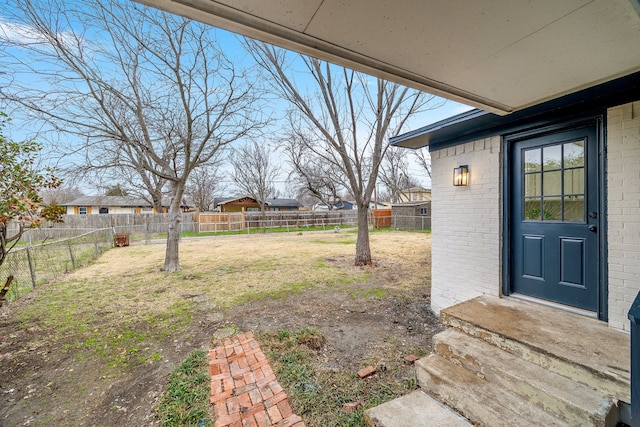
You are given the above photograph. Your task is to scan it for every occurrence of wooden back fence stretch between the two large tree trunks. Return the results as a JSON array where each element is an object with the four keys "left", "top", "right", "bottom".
[{"left": 194, "top": 210, "right": 358, "bottom": 232}]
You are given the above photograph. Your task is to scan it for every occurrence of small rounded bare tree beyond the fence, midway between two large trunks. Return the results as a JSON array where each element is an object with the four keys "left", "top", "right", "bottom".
[{"left": 231, "top": 141, "right": 280, "bottom": 212}]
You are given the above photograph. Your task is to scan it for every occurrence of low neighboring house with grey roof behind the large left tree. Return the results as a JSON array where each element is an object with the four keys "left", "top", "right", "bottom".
[{"left": 61, "top": 196, "right": 193, "bottom": 215}]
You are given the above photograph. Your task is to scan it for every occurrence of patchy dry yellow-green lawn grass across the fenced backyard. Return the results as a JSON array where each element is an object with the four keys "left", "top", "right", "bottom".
[{"left": 0, "top": 231, "right": 431, "bottom": 425}]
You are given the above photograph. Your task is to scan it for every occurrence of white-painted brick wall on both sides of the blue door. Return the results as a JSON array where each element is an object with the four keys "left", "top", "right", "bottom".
[{"left": 424, "top": 101, "right": 640, "bottom": 331}]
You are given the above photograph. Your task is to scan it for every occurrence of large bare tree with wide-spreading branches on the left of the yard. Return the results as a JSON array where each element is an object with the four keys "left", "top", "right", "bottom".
[{"left": 0, "top": 0, "right": 262, "bottom": 272}]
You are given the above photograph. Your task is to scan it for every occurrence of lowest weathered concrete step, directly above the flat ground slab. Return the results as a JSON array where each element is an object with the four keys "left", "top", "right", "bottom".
[{"left": 414, "top": 353, "right": 568, "bottom": 427}]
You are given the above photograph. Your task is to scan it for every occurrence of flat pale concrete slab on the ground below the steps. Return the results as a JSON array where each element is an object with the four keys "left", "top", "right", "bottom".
[{"left": 364, "top": 390, "right": 472, "bottom": 427}]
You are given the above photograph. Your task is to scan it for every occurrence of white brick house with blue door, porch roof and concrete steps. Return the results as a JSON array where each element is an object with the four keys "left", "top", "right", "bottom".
[{"left": 138, "top": 0, "right": 640, "bottom": 426}]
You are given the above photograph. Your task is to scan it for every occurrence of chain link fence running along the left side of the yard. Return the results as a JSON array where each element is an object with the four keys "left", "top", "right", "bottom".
[{"left": 0, "top": 228, "right": 113, "bottom": 302}]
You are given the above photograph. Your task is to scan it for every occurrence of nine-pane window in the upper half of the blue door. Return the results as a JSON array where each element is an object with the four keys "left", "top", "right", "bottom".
[{"left": 522, "top": 140, "right": 585, "bottom": 222}]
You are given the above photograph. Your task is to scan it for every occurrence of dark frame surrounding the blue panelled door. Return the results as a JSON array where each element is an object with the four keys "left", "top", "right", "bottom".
[{"left": 501, "top": 113, "right": 609, "bottom": 322}]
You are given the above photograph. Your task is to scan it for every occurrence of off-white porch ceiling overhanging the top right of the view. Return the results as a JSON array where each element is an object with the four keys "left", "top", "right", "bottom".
[{"left": 139, "top": 0, "right": 640, "bottom": 114}]
